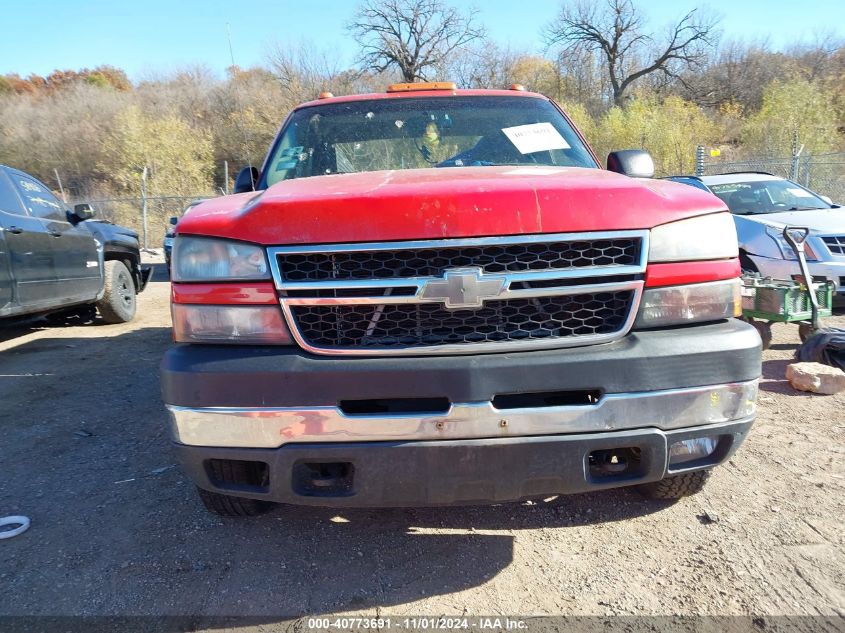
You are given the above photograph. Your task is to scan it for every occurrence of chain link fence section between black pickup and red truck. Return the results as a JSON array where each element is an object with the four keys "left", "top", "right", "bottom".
[{"left": 70, "top": 193, "right": 214, "bottom": 249}]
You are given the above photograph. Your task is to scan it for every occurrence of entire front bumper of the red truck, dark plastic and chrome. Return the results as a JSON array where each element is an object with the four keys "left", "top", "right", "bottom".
[{"left": 162, "top": 319, "right": 760, "bottom": 507}]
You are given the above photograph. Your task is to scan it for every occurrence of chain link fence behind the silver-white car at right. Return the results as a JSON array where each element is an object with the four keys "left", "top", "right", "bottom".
[{"left": 696, "top": 152, "right": 845, "bottom": 204}]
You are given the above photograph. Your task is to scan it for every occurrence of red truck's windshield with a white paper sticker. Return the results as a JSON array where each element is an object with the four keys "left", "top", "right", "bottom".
[{"left": 264, "top": 97, "right": 597, "bottom": 186}]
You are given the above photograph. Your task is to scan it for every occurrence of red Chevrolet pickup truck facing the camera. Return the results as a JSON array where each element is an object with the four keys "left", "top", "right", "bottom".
[{"left": 162, "top": 84, "right": 760, "bottom": 516}]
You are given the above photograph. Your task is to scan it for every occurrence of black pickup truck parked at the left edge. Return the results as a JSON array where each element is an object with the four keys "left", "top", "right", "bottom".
[{"left": 0, "top": 165, "right": 152, "bottom": 323}]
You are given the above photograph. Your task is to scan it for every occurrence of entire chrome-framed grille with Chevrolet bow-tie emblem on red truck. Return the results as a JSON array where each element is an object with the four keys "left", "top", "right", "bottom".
[{"left": 268, "top": 231, "right": 648, "bottom": 355}]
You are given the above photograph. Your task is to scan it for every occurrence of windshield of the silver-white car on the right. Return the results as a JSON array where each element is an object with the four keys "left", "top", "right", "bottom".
[{"left": 709, "top": 180, "right": 831, "bottom": 215}]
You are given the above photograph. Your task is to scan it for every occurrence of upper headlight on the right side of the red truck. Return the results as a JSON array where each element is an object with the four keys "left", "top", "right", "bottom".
[{"left": 648, "top": 213, "right": 739, "bottom": 262}]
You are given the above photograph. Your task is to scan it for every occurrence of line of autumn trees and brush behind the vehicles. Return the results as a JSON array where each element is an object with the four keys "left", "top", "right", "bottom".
[{"left": 0, "top": 0, "right": 845, "bottom": 216}]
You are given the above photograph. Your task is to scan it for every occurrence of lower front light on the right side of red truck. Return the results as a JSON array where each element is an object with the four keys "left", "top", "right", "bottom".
[{"left": 634, "top": 279, "right": 742, "bottom": 328}]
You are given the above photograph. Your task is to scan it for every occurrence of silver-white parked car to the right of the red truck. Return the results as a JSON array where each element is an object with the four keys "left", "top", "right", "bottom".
[{"left": 669, "top": 172, "right": 845, "bottom": 303}]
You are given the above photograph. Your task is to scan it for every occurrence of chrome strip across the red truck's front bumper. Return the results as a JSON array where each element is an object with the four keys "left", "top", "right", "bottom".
[{"left": 167, "top": 380, "right": 758, "bottom": 448}]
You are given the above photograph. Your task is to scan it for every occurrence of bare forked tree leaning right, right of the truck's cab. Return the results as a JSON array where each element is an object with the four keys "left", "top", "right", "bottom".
[{"left": 545, "top": 0, "right": 718, "bottom": 105}]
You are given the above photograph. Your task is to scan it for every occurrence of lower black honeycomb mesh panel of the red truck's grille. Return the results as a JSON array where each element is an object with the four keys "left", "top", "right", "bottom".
[{"left": 291, "top": 290, "right": 633, "bottom": 348}]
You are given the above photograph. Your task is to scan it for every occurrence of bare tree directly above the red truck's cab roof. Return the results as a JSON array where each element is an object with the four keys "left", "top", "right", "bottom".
[{"left": 347, "top": 0, "right": 484, "bottom": 81}]
